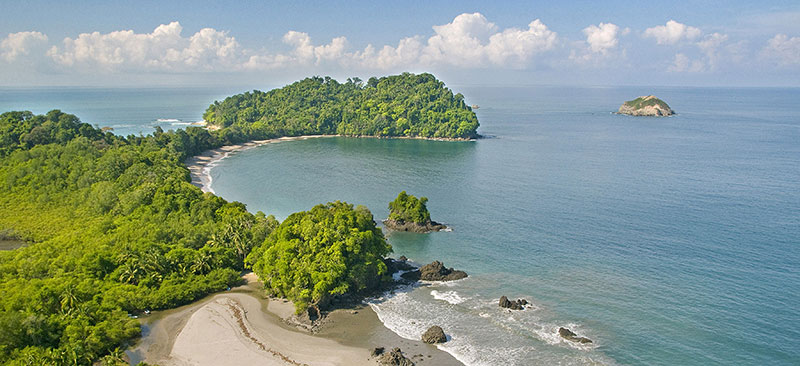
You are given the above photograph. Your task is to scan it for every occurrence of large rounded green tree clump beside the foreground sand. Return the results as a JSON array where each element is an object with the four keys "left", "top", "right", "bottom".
[{"left": 247, "top": 201, "right": 392, "bottom": 313}]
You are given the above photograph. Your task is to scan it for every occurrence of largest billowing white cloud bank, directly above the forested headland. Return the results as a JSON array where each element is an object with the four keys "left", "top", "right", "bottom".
[{"left": 253, "top": 13, "right": 557, "bottom": 70}]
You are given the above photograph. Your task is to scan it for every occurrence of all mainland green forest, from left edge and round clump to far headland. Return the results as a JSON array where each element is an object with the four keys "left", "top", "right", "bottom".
[{"left": 0, "top": 74, "right": 478, "bottom": 365}]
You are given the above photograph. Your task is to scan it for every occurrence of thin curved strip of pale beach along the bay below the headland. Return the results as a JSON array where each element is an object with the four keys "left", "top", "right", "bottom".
[{"left": 183, "top": 135, "right": 481, "bottom": 193}]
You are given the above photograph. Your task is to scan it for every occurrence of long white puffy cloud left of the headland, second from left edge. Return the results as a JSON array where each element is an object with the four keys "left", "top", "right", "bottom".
[{"left": 48, "top": 22, "right": 241, "bottom": 71}]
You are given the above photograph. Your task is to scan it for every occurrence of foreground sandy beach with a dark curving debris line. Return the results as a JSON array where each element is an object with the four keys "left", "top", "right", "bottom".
[{"left": 128, "top": 275, "right": 461, "bottom": 366}]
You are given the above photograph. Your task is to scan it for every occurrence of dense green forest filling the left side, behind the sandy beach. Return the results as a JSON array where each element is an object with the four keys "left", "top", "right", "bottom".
[{"left": 0, "top": 111, "right": 277, "bottom": 365}]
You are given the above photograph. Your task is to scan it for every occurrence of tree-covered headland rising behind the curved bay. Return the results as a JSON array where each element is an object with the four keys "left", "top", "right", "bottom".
[{"left": 203, "top": 73, "right": 478, "bottom": 139}]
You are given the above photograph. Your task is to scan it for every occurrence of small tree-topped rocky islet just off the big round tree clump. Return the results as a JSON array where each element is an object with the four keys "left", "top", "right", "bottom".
[{"left": 383, "top": 191, "right": 447, "bottom": 233}]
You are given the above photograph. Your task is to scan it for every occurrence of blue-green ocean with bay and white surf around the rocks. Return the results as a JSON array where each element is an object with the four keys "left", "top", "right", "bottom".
[{"left": 0, "top": 86, "right": 800, "bottom": 365}]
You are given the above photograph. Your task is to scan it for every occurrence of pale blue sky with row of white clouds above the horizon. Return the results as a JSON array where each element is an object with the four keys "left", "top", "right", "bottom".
[{"left": 0, "top": 0, "right": 800, "bottom": 87}]
